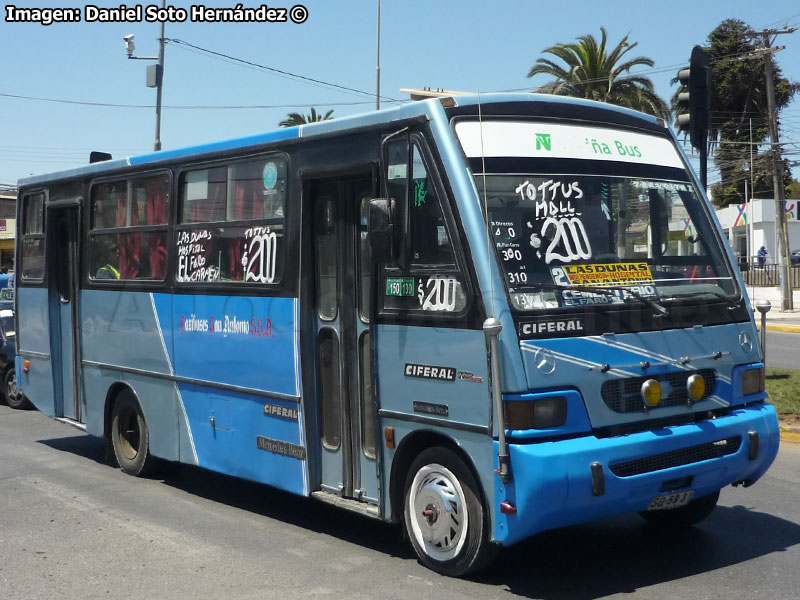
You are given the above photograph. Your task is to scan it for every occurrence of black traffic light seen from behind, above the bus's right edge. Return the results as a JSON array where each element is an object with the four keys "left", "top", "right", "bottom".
[{"left": 676, "top": 46, "right": 711, "bottom": 150}]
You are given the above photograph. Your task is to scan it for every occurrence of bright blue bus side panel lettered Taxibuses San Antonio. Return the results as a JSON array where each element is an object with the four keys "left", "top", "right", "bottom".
[{"left": 156, "top": 295, "right": 309, "bottom": 494}]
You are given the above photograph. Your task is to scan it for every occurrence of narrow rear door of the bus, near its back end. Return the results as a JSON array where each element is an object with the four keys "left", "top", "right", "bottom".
[{"left": 47, "top": 206, "right": 83, "bottom": 422}]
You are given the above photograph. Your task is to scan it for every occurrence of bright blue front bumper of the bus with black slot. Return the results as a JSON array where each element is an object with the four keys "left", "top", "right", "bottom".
[{"left": 493, "top": 404, "right": 780, "bottom": 545}]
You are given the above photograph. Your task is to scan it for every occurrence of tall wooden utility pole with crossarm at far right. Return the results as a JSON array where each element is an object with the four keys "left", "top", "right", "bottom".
[{"left": 758, "top": 27, "right": 797, "bottom": 310}]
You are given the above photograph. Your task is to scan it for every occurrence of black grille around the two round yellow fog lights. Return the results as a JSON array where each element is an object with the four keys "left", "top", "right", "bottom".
[{"left": 600, "top": 369, "right": 716, "bottom": 413}]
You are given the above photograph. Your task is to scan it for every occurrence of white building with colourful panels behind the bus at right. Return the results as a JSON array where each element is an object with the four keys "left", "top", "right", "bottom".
[{"left": 717, "top": 199, "right": 800, "bottom": 263}]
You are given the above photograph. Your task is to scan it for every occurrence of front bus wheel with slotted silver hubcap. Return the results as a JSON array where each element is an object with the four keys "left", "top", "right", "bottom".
[{"left": 403, "top": 446, "right": 497, "bottom": 577}]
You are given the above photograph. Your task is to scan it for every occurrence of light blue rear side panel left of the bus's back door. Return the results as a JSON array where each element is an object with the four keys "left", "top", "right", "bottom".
[{"left": 15, "top": 287, "right": 56, "bottom": 418}]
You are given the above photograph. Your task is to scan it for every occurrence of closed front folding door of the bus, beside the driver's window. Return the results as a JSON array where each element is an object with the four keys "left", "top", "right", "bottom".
[{"left": 310, "top": 175, "right": 379, "bottom": 504}]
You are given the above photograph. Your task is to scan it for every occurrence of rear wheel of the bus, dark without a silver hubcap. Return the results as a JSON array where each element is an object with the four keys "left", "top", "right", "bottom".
[{"left": 111, "top": 391, "right": 155, "bottom": 477}]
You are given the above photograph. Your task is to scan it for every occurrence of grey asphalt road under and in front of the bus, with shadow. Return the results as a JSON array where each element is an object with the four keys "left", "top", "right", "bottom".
[{"left": 0, "top": 406, "right": 800, "bottom": 600}]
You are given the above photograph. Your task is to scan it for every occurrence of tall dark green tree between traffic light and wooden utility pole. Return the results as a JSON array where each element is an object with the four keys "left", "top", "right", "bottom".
[{"left": 672, "top": 19, "right": 797, "bottom": 206}]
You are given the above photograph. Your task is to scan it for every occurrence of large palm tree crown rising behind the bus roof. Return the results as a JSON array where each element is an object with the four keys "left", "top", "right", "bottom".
[{"left": 528, "top": 27, "right": 670, "bottom": 119}]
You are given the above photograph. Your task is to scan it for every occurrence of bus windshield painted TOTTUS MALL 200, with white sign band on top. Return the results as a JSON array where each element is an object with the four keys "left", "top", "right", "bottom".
[{"left": 456, "top": 121, "right": 737, "bottom": 311}]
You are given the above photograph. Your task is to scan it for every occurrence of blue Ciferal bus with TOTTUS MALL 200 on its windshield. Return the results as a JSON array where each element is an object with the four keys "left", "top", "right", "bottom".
[{"left": 16, "top": 94, "right": 779, "bottom": 576}]
